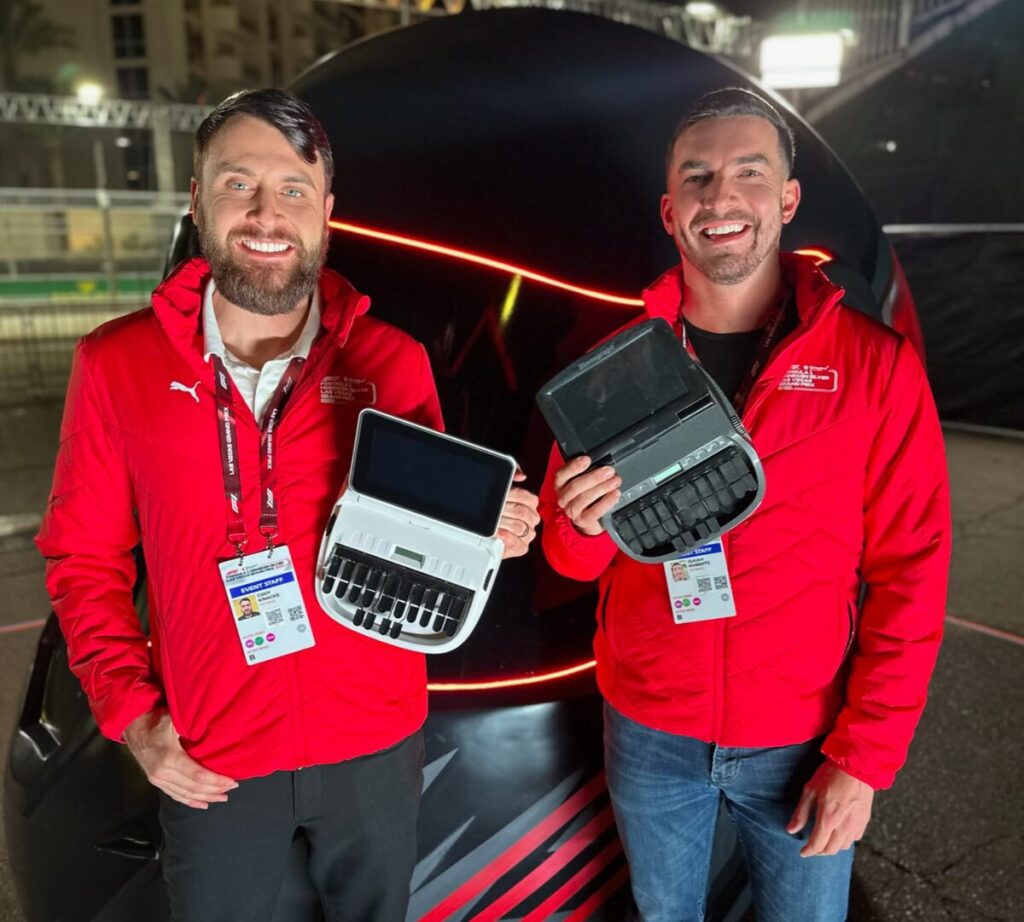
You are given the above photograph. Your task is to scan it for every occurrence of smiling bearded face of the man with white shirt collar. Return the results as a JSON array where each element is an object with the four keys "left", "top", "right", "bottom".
[{"left": 193, "top": 116, "right": 334, "bottom": 315}]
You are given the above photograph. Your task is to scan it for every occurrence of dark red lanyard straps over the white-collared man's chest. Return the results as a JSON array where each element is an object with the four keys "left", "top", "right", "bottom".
[{"left": 210, "top": 355, "right": 305, "bottom": 561}]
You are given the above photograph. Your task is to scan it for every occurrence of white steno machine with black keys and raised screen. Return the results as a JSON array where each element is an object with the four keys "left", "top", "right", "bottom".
[{"left": 316, "top": 410, "right": 515, "bottom": 653}]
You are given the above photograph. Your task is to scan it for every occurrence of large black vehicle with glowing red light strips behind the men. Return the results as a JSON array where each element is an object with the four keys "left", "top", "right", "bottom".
[{"left": 4, "top": 10, "right": 912, "bottom": 922}]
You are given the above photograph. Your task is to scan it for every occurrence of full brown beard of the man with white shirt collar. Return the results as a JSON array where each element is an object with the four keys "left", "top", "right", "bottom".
[{"left": 196, "top": 212, "right": 330, "bottom": 317}]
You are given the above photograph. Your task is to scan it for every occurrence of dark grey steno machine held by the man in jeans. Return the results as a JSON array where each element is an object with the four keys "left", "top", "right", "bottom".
[{"left": 537, "top": 319, "right": 765, "bottom": 563}]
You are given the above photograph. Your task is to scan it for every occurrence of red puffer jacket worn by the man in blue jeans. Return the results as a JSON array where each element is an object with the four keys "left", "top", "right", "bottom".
[{"left": 541, "top": 254, "right": 949, "bottom": 788}]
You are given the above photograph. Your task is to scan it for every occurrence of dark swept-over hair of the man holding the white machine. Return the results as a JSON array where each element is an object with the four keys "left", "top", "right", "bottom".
[{"left": 193, "top": 89, "right": 334, "bottom": 194}]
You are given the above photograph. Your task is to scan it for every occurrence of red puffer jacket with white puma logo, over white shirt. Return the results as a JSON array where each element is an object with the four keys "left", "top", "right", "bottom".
[{"left": 37, "top": 259, "right": 441, "bottom": 779}]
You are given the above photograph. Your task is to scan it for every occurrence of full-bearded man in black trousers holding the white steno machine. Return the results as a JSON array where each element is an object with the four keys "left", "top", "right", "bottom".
[{"left": 37, "top": 90, "right": 538, "bottom": 922}]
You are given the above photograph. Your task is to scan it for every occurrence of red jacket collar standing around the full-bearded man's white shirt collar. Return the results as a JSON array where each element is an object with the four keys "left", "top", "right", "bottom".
[{"left": 153, "top": 257, "right": 370, "bottom": 361}]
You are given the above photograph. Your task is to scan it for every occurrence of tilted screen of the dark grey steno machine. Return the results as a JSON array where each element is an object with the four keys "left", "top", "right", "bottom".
[{"left": 544, "top": 325, "right": 690, "bottom": 454}]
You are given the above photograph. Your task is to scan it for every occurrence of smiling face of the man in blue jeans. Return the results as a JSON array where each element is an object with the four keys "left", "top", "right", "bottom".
[{"left": 662, "top": 116, "right": 800, "bottom": 285}]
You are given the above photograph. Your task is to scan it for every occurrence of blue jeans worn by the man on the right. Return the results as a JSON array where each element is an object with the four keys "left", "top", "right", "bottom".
[{"left": 604, "top": 704, "right": 853, "bottom": 922}]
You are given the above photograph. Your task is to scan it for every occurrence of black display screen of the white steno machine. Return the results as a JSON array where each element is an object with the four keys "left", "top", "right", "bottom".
[{"left": 352, "top": 412, "right": 514, "bottom": 538}]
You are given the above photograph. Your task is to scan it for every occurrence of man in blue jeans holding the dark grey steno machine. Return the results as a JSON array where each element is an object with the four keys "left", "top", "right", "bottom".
[{"left": 541, "top": 88, "right": 949, "bottom": 922}]
